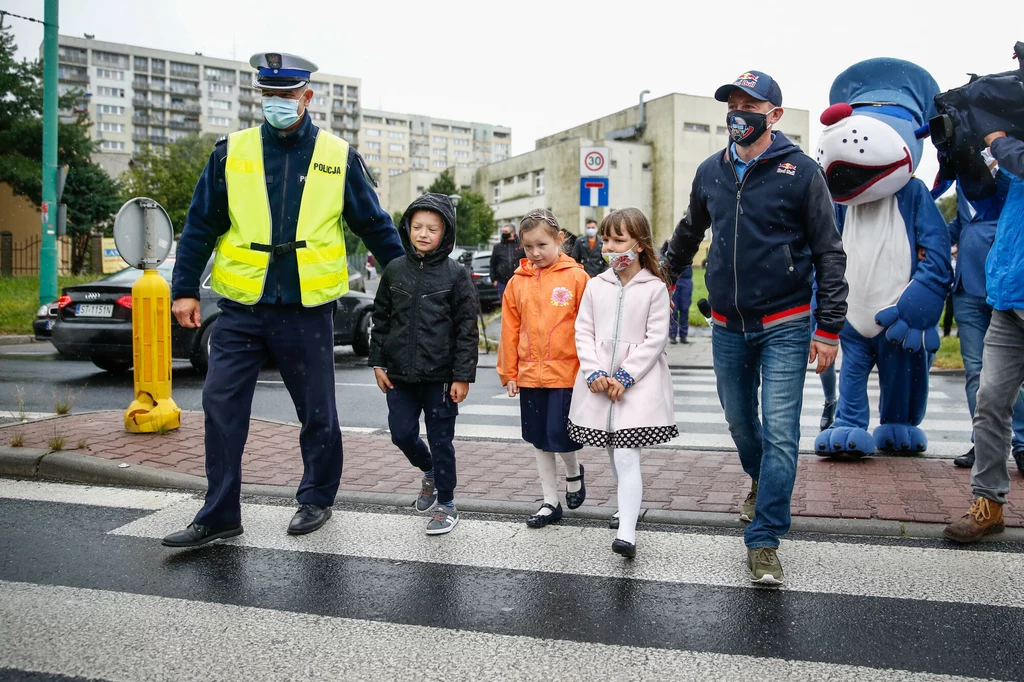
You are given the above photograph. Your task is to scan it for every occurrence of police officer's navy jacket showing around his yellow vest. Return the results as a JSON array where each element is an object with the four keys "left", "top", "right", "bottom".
[{"left": 171, "top": 114, "right": 406, "bottom": 305}]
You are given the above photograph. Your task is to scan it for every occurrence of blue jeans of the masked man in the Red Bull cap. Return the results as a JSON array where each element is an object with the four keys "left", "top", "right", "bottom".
[{"left": 712, "top": 321, "right": 811, "bottom": 549}]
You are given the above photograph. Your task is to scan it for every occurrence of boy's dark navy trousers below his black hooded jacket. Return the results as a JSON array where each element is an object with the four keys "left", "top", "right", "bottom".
[{"left": 387, "top": 381, "right": 459, "bottom": 503}]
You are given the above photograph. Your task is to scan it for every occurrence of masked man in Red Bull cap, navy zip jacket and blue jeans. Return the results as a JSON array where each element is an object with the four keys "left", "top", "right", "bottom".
[{"left": 666, "top": 72, "right": 847, "bottom": 585}]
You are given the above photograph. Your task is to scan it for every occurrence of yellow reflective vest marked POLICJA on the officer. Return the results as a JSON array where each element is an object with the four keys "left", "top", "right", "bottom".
[{"left": 211, "top": 127, "right": 348, "bottom": 307}]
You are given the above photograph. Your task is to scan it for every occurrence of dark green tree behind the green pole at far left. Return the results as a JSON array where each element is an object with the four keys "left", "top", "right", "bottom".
[{"left": 0, "top": 23, "right": 121, "bottom": 273}]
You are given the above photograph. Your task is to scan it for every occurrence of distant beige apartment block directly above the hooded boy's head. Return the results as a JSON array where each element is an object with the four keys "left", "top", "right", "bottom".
[{"left": 357, "top": 110, "right": 512, "bottom": 212}]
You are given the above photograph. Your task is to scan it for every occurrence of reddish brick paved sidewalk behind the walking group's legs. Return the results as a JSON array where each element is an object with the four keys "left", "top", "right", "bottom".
[{"left": 0, "top": 411, "right": 1024, "bottom": 526}]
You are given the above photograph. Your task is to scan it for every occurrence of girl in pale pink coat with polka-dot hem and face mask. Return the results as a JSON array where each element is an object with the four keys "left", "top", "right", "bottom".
[{"left": 568, "top": 208, "right": 679, "bottom": 558}]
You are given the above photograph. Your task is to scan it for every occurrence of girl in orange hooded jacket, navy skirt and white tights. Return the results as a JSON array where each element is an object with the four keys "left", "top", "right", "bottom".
[{"left": 498, "top": 209, "right": 589, "bottom": 528}]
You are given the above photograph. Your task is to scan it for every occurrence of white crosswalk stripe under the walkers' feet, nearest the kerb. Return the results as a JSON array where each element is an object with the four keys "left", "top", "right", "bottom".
[{"left": 111, "top": 493, "right": 1024, "bottom": 608}]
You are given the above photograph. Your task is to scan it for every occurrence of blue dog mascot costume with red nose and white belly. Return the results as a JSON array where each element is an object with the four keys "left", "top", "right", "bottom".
[{"left": 814, "top": 58, "right": 952, "bottom": 458}]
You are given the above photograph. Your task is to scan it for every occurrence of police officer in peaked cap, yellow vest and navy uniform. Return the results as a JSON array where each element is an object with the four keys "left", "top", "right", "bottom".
[{"left": 163, "top": 52, "right": 404, "bottom": 547}]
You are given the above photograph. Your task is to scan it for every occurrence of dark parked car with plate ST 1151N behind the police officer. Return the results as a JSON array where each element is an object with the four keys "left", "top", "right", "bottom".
[{"left": 50, "top": 258, "right": 373, "bottom": 374}]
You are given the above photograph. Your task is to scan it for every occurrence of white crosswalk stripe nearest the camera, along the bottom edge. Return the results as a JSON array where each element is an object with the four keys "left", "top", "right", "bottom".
[{"left": 0, "top": 582, "right": 964, "bottom": 682}]
